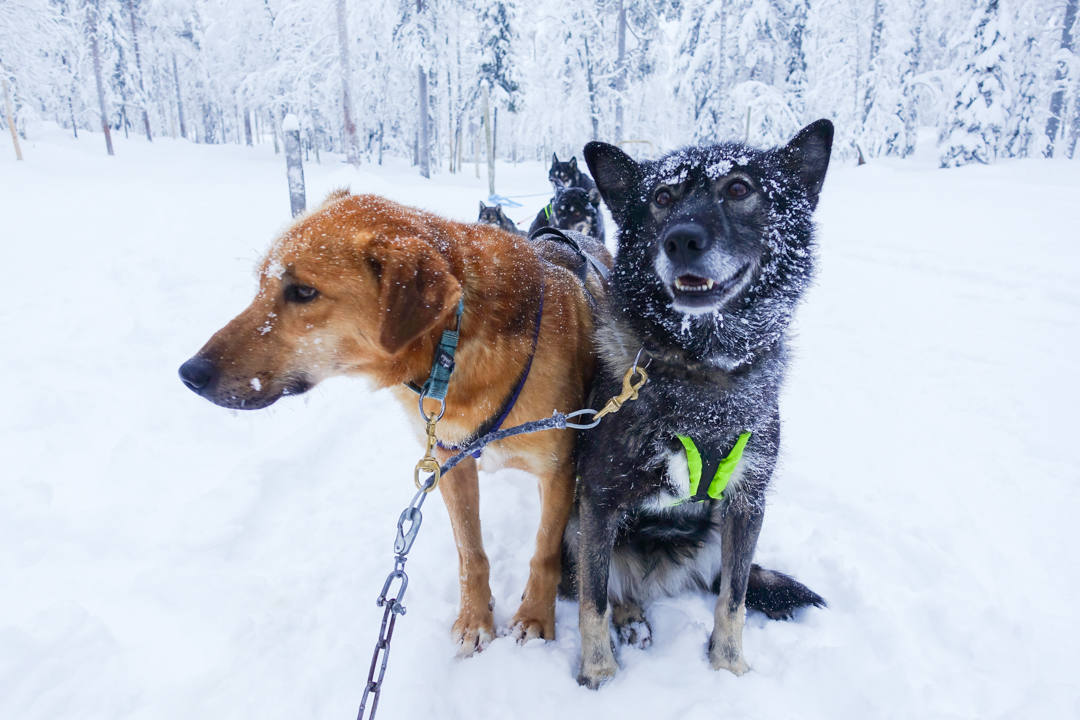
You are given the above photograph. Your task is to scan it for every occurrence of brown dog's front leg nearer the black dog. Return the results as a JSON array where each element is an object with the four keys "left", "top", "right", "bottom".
[{"left": 511, "top": 451, "right": 573, "bottom": 642}]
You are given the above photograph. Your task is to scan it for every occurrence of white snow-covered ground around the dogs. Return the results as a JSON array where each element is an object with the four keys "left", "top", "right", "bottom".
[{"left": 0, "top": 130, "right": 1080, "bottom": 720}]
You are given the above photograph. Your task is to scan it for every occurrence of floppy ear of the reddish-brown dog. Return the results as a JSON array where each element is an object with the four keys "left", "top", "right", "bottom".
[{"left": 372, "top": 237, "right": 461, "bottom": 355}]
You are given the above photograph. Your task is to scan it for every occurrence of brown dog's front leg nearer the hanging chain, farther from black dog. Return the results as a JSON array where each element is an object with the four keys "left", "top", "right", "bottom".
[{"left": 438, "top": 458, "right": 495, "bottom": 656}]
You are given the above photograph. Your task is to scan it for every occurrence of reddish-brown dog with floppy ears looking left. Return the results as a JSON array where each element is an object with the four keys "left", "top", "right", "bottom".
[{"left": 180, "top": 191, "right": 611, "bottom": 654}]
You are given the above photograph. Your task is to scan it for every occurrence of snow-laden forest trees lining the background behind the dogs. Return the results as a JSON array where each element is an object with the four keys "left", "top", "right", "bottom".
[{"left": 0, "top": 0, "right": 1080, "bottom": 173}]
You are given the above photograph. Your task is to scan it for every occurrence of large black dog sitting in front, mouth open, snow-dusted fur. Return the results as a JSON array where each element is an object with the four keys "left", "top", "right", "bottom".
[{"left": 566, "top": 120, "right": 833, "bottom": 688}]
